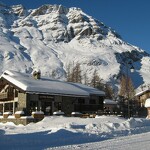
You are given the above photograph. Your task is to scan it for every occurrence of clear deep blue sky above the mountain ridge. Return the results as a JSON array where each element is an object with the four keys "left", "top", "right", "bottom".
[{"left": 0, "top": 0, "right": 150, "bottom": 53}]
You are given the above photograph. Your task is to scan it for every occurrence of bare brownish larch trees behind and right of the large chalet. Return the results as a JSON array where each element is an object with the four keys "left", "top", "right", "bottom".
[{"left": 52, "top": 62, "right": 135, "bottom": 100}]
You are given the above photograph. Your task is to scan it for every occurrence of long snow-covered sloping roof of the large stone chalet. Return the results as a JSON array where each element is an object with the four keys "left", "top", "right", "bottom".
[{"left": 1, "top": 70, "right": 105, "bottom": 97}]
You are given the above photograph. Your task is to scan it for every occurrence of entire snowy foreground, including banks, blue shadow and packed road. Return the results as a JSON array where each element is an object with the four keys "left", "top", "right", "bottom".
[{"left": 0, "top": 116, "right": 150, "bottom": 150}]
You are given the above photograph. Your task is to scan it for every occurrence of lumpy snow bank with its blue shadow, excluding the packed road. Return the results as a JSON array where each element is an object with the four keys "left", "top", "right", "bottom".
[{"left": 0, "top": 116, "right": 150, "bottom": 149}]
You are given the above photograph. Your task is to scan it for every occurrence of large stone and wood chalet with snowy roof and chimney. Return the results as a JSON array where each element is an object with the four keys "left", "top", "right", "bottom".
[{"left": 0, "top": 70, "right": 105, "bottom": 116}]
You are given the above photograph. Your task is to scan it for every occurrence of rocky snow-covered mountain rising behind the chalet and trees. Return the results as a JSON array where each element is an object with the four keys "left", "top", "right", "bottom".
[{"left": 0, "top": 3, "right": 150, "bottom": 88}]
